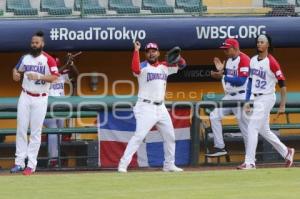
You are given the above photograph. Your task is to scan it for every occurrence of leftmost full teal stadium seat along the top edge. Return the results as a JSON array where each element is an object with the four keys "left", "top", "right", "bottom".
[{"left": 6, "top": 0, "right": 38, "bottom": 15}]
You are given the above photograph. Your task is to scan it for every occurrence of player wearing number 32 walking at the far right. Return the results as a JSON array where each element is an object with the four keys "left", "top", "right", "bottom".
[{"left": 238, "top": 35, "right": 295, "bottom": 169}]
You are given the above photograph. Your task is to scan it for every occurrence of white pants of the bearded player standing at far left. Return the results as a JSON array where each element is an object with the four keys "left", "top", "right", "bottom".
[{"left": 15, "top": 92, "right": 48, "bottom": 171}]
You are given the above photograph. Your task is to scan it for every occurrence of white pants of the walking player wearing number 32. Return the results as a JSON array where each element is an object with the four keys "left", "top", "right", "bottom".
[{"left": 245, "top": 93, "right": 288, "bottom": 165}]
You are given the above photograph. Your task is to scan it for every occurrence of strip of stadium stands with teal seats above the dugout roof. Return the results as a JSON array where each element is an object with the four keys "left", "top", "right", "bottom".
[{"left": 0, "top": 0, "right": 300, "bottom": 17}]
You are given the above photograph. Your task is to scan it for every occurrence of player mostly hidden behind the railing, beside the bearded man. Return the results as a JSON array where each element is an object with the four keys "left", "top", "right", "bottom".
[{"left": 44, "top": 57, "right": 78, "bottom": 167}]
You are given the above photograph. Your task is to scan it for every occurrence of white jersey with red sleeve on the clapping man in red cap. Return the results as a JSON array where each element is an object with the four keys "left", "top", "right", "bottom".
[{"left": 224, "top": 52, "right": 250, "bottom": 93}]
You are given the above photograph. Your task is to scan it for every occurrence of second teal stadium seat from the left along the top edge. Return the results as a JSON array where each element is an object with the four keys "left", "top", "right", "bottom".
[{"left": 40, "top": 0, "right": 72, "bottom": 15}]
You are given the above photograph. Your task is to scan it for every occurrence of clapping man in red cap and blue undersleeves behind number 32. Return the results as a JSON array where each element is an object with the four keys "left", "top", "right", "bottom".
[{"left": 206, "top": 39, "right": 250, "bottom": 157}]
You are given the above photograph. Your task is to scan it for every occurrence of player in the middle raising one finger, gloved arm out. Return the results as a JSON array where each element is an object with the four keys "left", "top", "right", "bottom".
[{"left": 118, "top": 42, "right": 186, "bottom": 173}]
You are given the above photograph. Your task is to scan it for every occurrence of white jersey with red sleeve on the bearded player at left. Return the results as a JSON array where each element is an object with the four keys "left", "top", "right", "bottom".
[{"left": 16, "top": 52, "right": 59, "bottom": 93}]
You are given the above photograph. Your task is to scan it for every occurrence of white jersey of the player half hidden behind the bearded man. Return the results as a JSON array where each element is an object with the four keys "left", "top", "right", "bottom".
[{"left": 49, "top": 71, "right": 69, "bottom": 96}]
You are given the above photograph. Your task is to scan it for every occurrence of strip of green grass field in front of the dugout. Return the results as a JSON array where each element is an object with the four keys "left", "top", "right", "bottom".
[{"left": 0, "top": 168, "right": 300, "bottom": 199}]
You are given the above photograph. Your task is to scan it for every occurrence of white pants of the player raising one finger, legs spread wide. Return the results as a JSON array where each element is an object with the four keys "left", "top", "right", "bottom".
[{"left": 120, "top": 101, "right": 175, "bottom": 167}]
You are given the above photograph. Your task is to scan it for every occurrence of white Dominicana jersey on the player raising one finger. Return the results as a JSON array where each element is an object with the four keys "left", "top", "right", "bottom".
[{"left": 135, "top": 61, "right": 179, "bottom": 102}]
